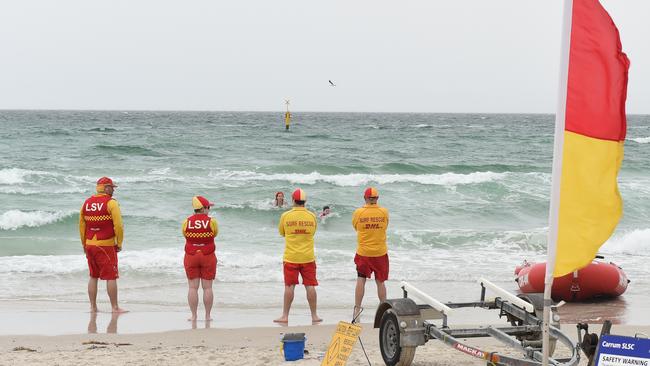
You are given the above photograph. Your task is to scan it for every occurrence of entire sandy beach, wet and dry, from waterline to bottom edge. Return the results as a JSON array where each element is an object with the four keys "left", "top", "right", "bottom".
[{"left": 0, "top": 278, "right": 650, "bottom": 366}]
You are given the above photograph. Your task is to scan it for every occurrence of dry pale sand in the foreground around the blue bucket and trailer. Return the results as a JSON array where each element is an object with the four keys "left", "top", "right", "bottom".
[{"left": 0, "top": 324, "right": 650, "bottom": 366}]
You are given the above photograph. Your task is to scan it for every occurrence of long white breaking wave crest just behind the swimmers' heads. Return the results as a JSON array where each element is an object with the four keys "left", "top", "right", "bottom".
[{"left": 210, "top": 171, "right": 508, "bottom": 187}]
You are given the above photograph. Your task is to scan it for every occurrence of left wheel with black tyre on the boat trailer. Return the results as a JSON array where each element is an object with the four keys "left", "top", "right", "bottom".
[{"left": 379, "top": 309, "right": 415, "bottom": 366}]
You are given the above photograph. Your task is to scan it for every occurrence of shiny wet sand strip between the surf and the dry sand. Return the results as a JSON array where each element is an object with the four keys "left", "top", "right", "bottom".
[{"left": 0, "top": 288, "right": 650, "bottom": 336}]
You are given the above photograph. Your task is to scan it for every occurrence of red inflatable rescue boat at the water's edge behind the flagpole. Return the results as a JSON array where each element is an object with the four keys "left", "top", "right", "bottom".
[{"left": 515, "top": 260, "right": 630, "bottom": 302}]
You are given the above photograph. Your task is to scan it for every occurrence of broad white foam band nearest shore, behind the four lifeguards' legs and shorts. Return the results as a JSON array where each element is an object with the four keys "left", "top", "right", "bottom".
[{"left": 0, "top": 228, "right": 650, "bottom": 286}]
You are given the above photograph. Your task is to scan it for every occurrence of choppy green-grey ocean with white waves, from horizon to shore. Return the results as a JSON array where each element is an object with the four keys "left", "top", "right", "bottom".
[{"left": 0, "top": 111, "right": 650, "bottom": 330}]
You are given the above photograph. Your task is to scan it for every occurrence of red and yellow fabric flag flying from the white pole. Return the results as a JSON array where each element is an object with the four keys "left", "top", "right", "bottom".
[{"left": 553, "top": 0, "right": 630, "bottom": 277}]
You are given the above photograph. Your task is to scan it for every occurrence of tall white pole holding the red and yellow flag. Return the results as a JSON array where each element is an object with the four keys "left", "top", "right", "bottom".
[{"left": 542, "top": 0, "right": 573, "bottom": 366}]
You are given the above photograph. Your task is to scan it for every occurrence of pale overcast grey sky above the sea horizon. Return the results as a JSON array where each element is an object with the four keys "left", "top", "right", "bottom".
[{"left": 0, "top": 0, "right": 650, "bottom": 114}]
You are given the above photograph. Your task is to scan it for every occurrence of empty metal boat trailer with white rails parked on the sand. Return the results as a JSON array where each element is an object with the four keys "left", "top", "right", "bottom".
[{"left": 374, "top": 279, "right": 581, "bottom": 366}]
